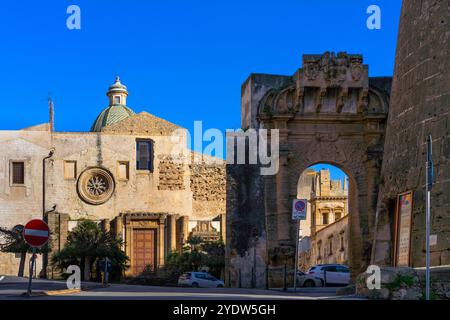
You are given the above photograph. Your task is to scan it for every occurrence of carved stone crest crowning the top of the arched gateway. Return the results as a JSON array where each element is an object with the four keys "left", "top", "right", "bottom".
[{"left": 259, "top": 52, "right": 390, "bottom": 119}]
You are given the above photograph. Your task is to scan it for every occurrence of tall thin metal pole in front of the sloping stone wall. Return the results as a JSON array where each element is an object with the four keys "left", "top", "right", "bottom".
[{"left": 425, "top": 135, "right": 434, "bottom": 300}]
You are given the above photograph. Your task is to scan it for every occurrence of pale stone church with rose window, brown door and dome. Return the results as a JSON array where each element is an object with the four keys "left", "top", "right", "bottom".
[{"left": 0, "top": 79, "right": 225, "bottom": 275}]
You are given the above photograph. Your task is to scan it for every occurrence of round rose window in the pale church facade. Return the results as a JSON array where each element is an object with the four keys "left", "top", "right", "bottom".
[{"left": 77, "top": 168, "right": 115, "bottom": 205}]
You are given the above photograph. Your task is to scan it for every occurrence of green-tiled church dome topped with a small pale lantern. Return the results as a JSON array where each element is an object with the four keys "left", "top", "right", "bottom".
[{"left": 91, "top": 77, "right": 136, "bottom": 132}]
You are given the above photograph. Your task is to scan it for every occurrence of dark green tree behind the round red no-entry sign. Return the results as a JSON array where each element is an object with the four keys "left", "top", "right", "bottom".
[{"left": 0, "top": 225, "right": 50, "bottom": 277}]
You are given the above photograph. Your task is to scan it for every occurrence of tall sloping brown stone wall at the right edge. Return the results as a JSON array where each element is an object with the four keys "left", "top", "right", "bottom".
[{"left": 372, "top": 0, "right": 450, "bottom": 267}]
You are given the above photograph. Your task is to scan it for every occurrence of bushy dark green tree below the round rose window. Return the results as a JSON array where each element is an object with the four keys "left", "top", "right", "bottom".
[{"left": 52, "top": 220, "right": 129, "bottom": 280}]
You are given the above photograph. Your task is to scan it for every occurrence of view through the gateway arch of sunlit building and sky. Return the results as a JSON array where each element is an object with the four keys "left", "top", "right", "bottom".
[{"left": 295, "top": 163, "right": 355, "bottom": 272}]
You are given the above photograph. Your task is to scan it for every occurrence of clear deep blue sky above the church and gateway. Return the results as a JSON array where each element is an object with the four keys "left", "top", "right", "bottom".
[{"left": 0, "top": 0, "right": 401, "bottom": 180}]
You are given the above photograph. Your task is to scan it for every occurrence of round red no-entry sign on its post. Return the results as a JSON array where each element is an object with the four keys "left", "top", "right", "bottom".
[{"left": 23, "top": 219, "right": 50, "bottom": 296}]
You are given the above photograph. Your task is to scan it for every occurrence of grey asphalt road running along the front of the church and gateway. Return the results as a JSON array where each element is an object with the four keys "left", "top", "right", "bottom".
[{"left": 0, "top": 276, "right": 353, "bottom": 300}]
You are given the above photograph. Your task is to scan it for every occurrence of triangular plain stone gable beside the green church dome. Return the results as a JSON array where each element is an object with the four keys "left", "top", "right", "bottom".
[{"left": 102, "top": 112, "right": 182, "bottom": 136}]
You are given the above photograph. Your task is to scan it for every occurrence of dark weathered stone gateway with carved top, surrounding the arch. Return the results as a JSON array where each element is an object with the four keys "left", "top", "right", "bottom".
[{"left": 226, "top": 52, "right": 391, "bottom": 287}]
